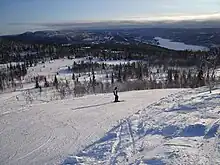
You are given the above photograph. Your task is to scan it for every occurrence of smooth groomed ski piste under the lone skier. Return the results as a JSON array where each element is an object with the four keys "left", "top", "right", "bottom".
[{"left": 0, "top": 89, "right": 182, "bottom": 165}]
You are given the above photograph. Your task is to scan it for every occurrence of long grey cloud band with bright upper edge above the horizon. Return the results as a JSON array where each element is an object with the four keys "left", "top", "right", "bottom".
[{"left": 6, "top": 13, "right": 220, "bottom": 30}]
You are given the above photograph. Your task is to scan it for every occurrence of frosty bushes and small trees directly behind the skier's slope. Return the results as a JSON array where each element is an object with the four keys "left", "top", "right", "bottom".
[{"left": 31, "top": 70, "right": 206, "bottom": 99}]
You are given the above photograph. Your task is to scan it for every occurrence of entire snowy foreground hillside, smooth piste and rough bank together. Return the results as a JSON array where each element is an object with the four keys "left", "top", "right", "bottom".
[{"left": 0, "top": 85, "right": 220, "bottom": 165}]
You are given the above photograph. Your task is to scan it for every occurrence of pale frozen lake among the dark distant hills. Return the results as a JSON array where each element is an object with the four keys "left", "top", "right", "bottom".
[{"left": 154, "top": 37, "right": 208, "bottom": 51}]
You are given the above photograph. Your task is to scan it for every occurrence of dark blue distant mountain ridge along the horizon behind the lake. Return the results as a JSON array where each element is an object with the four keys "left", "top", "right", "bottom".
[{"left": 1, "top": 26, "right": 220, "bottom": 47}]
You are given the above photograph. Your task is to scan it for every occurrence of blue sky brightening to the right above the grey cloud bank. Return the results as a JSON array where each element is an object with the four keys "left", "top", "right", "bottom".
[{"left": 0, "top": 0, "right": 220, "bottom": 35}]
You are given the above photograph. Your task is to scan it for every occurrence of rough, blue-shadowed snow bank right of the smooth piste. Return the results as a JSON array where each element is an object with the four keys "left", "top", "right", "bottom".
[{"left": 63, "top": 88, "right": 220, "bottom": 165}]
